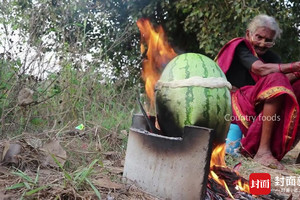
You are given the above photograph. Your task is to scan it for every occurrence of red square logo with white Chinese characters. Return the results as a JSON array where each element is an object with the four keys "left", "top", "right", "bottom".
[{"left": 249, "top": 173, "right": 271, "bottom": 195}]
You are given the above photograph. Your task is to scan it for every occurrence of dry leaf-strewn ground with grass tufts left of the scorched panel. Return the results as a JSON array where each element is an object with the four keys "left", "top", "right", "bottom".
[{"left": 0, "top": 133, "right": 159, "bottom": 200}]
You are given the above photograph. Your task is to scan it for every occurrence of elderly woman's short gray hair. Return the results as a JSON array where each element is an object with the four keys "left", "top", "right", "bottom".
[{"left": 248, "top": 14, "right": 282, "bottom": 39}]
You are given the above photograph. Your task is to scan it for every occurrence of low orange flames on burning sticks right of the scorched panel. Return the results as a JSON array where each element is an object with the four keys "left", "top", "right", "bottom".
[{"left": 209, "top": 143, "right": 250, "bottom": 199}]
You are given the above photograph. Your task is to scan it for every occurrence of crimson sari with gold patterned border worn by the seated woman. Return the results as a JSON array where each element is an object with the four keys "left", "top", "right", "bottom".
[{"left": 216, "top": 38, "right": 300, "bottom": 160}]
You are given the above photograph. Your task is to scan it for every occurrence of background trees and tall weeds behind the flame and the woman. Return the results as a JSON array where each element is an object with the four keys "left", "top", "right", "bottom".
[{"left": 0, "top": 0, "right": 300, "bottom": 137}]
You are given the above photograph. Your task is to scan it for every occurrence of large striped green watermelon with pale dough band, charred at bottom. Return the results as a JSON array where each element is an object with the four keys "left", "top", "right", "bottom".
[{"left": 155, "top": 53, "right": 232, "bottom": 143}]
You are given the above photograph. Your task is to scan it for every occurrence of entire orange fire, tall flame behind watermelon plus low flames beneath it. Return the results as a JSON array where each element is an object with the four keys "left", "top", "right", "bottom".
[{"left": 137, "top": 19, "right": 250, "bottom": 199}]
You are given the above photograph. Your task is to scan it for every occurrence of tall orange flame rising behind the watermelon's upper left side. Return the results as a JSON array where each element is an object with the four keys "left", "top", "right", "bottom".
[{"left": 137, "top": 19, "right": 177, "bottom": 106}]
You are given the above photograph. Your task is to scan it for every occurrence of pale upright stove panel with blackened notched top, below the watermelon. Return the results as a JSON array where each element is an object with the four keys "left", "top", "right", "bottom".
[{"left": 123, "top": 114, "right": 214, "bottom": 200}]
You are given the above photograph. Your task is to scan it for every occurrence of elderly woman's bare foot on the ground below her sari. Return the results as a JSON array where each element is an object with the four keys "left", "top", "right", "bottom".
[{"left": 253, "top": 152, "right": 285, "bottom": 170}]
